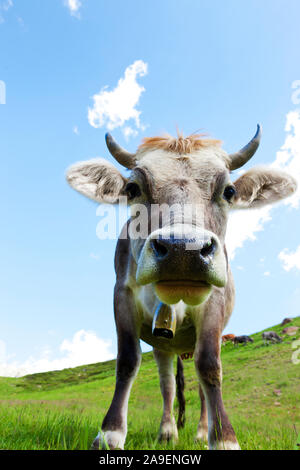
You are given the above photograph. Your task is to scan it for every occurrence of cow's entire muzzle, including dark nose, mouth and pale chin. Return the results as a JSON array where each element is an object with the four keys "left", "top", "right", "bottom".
[{"left": 136, "top": 226, "right": 227, "bottom": 305}]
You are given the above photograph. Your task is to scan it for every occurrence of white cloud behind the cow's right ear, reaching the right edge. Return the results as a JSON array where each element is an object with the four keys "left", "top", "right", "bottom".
[{"left": 226, "top": 110, "right": 300, "bottom": 259}]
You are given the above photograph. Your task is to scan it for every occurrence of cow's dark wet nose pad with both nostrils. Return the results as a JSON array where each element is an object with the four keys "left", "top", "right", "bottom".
[{"left": 150, "top": 236, "right": 217, "bottom": 262}]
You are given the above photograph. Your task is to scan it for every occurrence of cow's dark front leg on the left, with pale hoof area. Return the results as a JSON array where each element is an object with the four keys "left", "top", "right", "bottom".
[{"left": 93, "top": 286, "right": 141, "bottom": 449}]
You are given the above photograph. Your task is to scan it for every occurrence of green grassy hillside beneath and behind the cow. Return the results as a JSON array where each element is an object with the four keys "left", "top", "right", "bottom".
[{"left": 0, "top": 317, "right": 300, "bottom": 449}]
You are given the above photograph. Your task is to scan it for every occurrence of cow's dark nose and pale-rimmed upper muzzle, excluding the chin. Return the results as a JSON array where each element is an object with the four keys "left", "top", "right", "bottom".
[{"left": 136, "top": 225, "right": 226, "bottom": 287}]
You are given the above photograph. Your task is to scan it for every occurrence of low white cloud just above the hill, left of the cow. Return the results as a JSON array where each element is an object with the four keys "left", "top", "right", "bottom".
[{"left": 0, "top": 330, "right": 114, "bottom": 377}]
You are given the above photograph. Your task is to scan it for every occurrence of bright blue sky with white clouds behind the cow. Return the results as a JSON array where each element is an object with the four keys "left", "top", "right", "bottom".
[{"left": 0, "top": 0, "right": 300, "bottom": 375}]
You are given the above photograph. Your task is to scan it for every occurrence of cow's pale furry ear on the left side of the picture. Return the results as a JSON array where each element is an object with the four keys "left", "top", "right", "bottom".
[{"left": 66, "top": 158, "right": 127, "bottom": 204}]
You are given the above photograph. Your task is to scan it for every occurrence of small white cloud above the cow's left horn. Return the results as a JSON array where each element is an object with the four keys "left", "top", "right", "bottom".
[{"left": 88, "top": 60, "right": 148, "bottom": 139}]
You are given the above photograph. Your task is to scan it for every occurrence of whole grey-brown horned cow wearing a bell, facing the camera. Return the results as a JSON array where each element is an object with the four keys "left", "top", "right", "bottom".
[{"left": 66, "top": 125, "right": 296, "bottom": 450}]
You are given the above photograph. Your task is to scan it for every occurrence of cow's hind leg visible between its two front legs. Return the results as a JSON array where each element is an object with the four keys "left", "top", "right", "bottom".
[{"left": 153, "top": 349, "right": 178, "bottom": 441}]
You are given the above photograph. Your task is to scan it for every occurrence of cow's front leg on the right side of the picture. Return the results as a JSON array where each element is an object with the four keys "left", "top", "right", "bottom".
[{"left": 195, "top": 321, "right": 239, "bottom": 450}]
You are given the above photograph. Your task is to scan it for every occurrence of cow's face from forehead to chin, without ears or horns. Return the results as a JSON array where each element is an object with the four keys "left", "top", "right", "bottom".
[{"left": 125, "top": 146, "right": 235, "bottom": 305}]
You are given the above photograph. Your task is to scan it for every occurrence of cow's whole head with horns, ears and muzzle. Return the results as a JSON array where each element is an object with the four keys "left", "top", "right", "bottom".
[{"left": 67, "top": 126, "right": 296, "bottom": 305}]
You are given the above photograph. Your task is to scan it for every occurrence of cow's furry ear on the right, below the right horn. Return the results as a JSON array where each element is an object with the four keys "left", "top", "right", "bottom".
[{"left": 232, "top": 167, "right": 297, "bottom": 209}]
